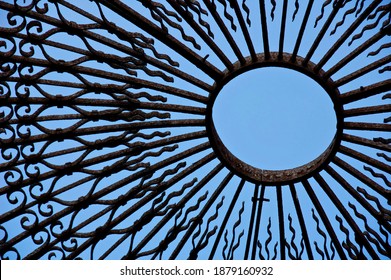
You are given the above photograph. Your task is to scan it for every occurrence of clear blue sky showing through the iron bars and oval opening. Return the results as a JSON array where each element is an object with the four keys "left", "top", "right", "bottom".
[{"left": 0, "top": 1, "right": 390, "bottom": 259}]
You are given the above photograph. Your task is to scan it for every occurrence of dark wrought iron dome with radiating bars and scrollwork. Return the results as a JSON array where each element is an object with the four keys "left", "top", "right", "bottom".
[{"left": 0, "top": 0, "right": 391, "bottom": 259}]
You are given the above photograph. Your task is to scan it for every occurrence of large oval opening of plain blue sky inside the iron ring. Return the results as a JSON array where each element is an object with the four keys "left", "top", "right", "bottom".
[{"left": 212, "top": 67, "right": 337, "bottom": 170}]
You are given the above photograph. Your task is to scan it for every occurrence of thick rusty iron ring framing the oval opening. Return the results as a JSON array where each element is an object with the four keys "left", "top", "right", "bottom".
[{"left": 206, "top": 52, "right": 343, "bottom": 186}]
